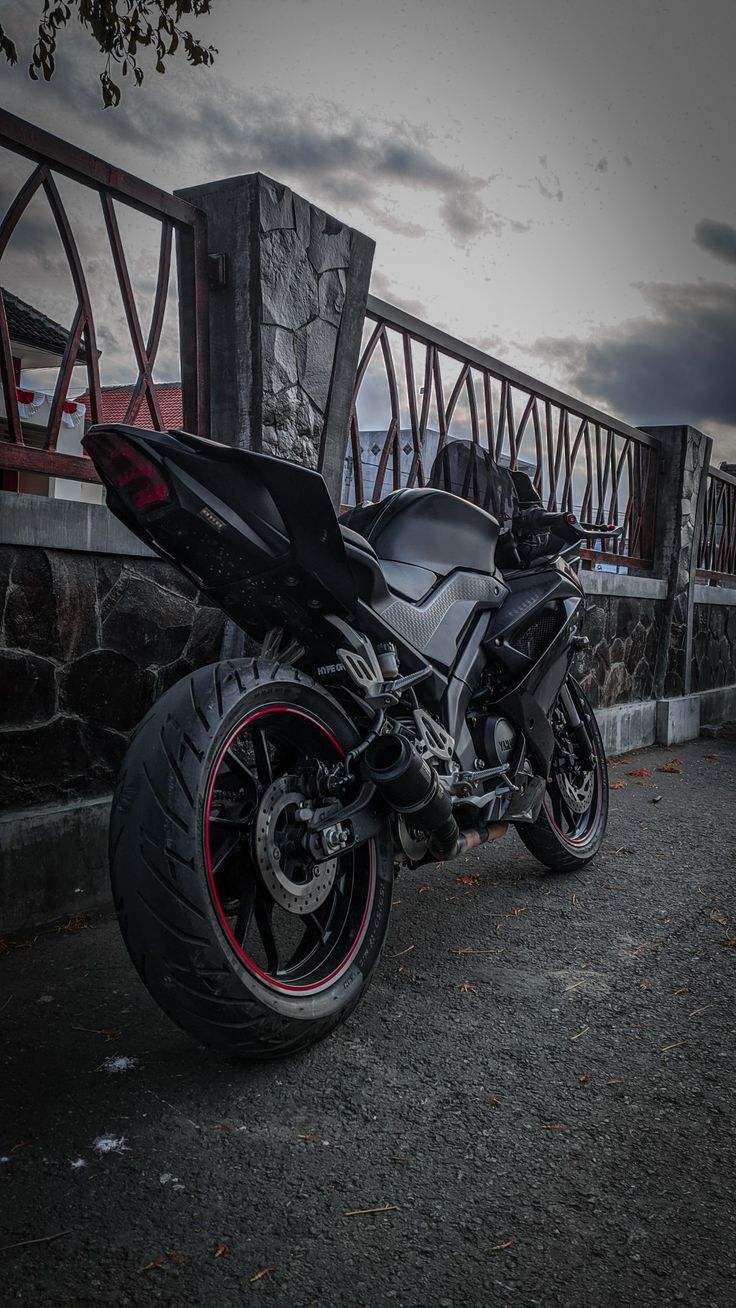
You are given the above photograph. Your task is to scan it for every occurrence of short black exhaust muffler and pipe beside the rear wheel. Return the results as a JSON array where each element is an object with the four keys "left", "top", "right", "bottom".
[{"left": 362, "top": 734, "right": 506, "bottom": 863}]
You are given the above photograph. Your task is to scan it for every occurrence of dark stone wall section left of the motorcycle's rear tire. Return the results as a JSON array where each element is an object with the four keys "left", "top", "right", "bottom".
[{"left": 0, "top": 545, "right": 224, "bottom": 810}]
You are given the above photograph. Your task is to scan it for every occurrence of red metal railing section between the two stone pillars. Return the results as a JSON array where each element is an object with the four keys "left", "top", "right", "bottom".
[{"left": 343, "top": 296, "right": 659, "bottom": 570}]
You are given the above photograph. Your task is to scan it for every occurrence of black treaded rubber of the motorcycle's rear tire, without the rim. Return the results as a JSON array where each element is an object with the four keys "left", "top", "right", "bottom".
[{"left": 110, "top": 659, "right": 389, "bottom": 1059}]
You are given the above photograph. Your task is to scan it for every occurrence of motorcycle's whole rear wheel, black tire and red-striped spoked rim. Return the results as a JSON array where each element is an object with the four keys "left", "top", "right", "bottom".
[{"left": 111, "top": 661, "right": 392, "bottom": 1058}]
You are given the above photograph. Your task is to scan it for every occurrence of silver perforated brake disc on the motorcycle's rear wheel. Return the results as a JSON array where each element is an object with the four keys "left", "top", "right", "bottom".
[{"left": 255, "top": 777, "right": 337, "bottom": 916}]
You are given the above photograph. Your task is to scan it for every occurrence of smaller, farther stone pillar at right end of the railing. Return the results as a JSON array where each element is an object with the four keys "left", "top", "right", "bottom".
[{"left": 643, "top": 426, "right": 712, "bottom": 698}]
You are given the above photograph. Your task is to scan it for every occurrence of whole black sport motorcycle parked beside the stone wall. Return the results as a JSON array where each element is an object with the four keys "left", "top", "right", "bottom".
[{"left": 84, "top": 426, "right": 617, "bottom": 1058}]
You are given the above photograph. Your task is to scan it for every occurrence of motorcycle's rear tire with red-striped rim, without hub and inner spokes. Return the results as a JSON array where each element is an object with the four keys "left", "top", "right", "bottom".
[{"left": 110, "top": 659, "right": 393, "bottom": 1059}]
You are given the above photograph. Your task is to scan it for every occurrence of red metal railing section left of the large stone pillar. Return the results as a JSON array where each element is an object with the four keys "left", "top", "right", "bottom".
[{"left": 0, "top": 110, "right": 209, "bottom": 481}]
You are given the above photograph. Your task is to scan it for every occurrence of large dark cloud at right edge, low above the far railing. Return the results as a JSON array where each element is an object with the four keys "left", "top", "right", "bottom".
[{"left": 533, "top": 283, "right": 736, "bottom": 428}]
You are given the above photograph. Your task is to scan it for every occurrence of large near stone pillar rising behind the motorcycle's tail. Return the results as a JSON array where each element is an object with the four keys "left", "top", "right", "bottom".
[{"left": 178, "top": 173, "right": 374, "bottom": 504}]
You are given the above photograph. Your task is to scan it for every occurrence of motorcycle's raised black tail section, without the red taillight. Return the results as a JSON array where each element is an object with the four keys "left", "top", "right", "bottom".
[{"left": 84, "top": 425, "right": 357, "bottom": 628}]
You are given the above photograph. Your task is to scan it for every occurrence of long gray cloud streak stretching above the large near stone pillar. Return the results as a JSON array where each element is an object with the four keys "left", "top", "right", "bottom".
[{"left": 1, "top": 54, "right": 519, "bottom": 243}]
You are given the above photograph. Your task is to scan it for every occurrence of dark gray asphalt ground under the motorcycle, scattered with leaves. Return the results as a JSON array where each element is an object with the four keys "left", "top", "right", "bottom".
[{"left": 0, "top": 740, "right": 736, "bottom": 1308}]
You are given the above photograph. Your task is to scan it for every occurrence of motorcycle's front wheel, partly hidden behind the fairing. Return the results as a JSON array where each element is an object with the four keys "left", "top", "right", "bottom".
[{"left": 516, "top": 678, "right": 608, "bottom": 872}]
